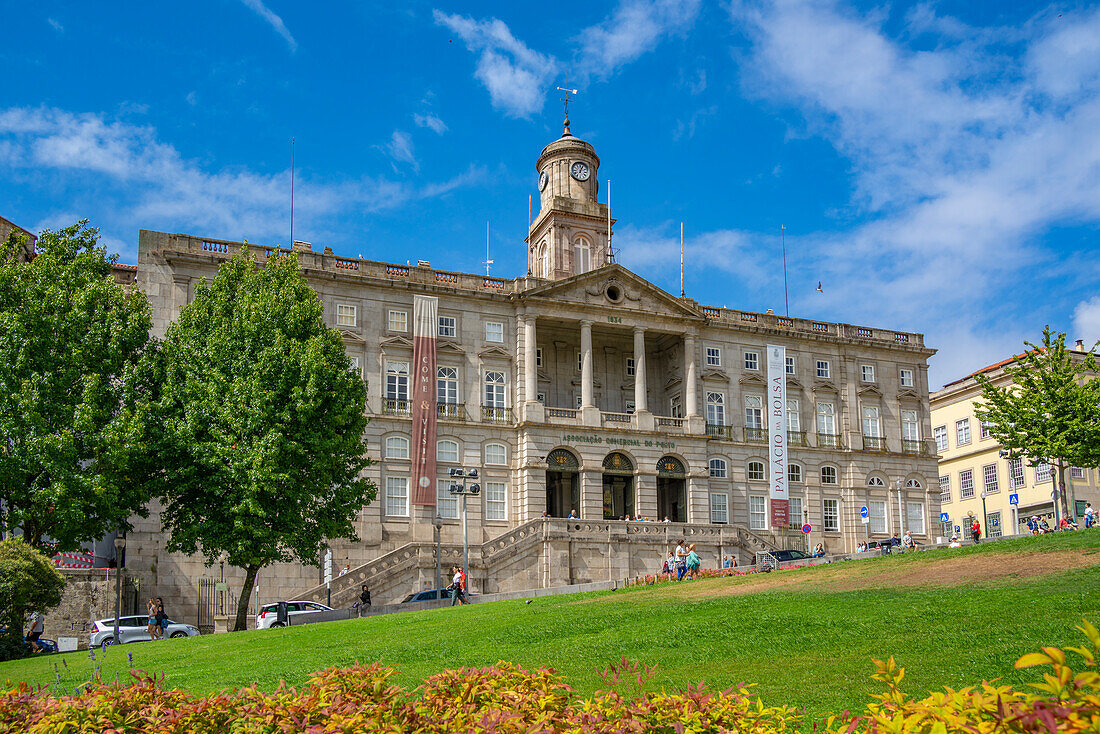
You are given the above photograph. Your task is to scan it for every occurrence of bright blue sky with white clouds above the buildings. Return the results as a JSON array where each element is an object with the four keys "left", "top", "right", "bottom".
[{"left": 0, "top": 0, "right": 1100, "bottom": 387}]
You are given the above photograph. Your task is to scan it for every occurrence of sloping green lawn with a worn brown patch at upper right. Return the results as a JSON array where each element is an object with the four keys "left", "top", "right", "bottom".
[{"left": 0, "top": 532, "right": 1100, "bottom": 712}]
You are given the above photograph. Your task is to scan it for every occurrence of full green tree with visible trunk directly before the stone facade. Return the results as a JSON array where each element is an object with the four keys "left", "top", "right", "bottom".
[{"left": 149, "top": 249, "right": 376, "bottom": 629}]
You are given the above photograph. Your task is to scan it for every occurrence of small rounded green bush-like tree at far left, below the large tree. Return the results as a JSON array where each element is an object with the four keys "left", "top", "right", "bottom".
[{"left": 0, "top": 538, "right": 65, "bottom": 660}]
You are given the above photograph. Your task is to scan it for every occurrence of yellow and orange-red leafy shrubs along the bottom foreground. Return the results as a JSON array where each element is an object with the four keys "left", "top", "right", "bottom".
[{"left": 0, "top": 622, "right": 1100, "bottom": 734}]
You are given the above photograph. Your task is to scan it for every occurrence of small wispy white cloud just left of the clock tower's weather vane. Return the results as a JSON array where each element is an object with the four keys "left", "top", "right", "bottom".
[{"left": 433, "top": 10, "right": 558, "bottom": 118}]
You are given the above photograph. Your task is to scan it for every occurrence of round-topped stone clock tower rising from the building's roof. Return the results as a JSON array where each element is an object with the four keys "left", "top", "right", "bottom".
[{"left": 527, "top": 118, "right": 613, "bottom": 281}]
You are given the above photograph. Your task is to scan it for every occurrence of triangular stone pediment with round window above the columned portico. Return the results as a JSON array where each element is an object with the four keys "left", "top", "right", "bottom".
[{"left": 519, "top": 263, "right": 704, "bottom": 320}]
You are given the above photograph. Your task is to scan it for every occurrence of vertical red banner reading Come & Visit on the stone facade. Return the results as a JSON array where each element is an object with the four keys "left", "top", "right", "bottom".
[{"left": 409, "top": 296, "right": 439, "bottom": 507}]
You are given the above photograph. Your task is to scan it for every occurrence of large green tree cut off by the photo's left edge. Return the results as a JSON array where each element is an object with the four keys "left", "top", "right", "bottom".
[{"left": 0, "top": 220, "right": 150, "bottom": 551}]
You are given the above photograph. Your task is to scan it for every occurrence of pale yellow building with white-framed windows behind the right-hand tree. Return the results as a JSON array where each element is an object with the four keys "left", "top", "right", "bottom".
[{"left": 931, "top": 341, "right": 1100, "bottom": 538}]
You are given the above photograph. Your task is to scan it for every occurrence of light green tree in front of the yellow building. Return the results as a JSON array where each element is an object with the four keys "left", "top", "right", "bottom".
[{"left": 975, "top": 326, "right": 1100, "bottom": 517}]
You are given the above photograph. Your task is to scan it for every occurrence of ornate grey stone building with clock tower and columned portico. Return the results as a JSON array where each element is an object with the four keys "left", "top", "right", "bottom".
[{"left": 128, "top": 123, "right": 939, "bottom": 625}]
